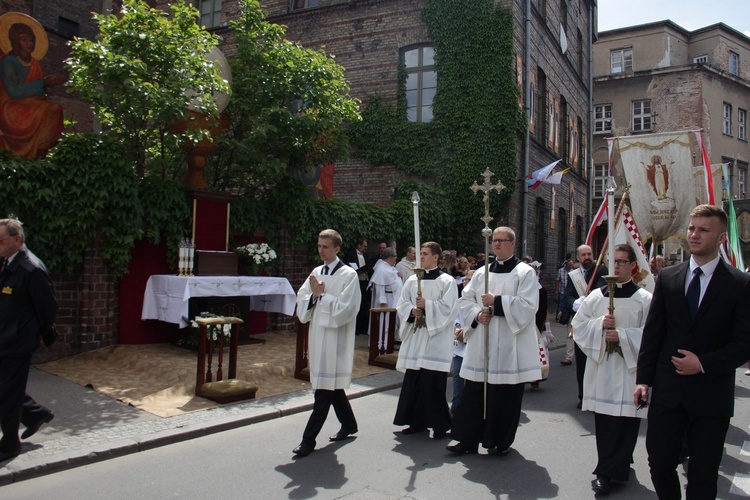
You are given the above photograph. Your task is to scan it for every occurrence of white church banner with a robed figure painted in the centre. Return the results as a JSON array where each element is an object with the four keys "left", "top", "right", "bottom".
[{"left": 613, "top": 131, "right": 697, "bottom": 242}]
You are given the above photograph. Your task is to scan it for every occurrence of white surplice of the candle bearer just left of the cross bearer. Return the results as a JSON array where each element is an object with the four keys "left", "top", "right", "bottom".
[{"left": 396, "top": 273, "right": 458, "bottom": 372}]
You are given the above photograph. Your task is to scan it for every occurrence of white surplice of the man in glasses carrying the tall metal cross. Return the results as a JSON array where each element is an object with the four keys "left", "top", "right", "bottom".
[{"left": 459, "top": 263, "right": 542, "bottom": 384}]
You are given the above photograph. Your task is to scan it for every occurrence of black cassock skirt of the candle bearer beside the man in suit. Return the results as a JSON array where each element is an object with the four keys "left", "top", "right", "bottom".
[{"left": 594, "top": 413, "right": 641, "bottom": 481}]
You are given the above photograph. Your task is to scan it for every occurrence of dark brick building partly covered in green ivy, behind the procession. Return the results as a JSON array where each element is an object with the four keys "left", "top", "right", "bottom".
[{"left": 229, "top": 0, "right": 596, "bottom": 284}]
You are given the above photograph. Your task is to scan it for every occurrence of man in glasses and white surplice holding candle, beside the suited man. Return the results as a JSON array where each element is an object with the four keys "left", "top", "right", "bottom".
[{"left": 571, "top": 245, "right": 651, "bottom": 494}]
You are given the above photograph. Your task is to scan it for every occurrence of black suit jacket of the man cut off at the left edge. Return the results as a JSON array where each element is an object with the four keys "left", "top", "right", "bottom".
[{"left": 0, "top": 250, "right": 57, "bottom": 357}]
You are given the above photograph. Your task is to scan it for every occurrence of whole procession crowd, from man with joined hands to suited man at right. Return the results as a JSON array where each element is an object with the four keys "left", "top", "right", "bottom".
[{"left": 294, "top": 205, "right": 750, "bottom": 499}]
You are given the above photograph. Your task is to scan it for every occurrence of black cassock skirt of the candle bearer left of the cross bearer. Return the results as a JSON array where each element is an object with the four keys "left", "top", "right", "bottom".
[{"left": 393, "top": 368, "right": 451, "bottom": 432}]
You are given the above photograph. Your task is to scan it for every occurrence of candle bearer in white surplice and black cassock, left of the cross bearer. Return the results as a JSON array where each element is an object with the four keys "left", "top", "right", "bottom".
[{"left": 393, "top": 242, "right": 458, "bottom": 438}]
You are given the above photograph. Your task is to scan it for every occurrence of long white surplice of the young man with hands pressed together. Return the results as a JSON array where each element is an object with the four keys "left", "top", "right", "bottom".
[{"left": 297, "top": 265, "right": 362, "bottom": 390}]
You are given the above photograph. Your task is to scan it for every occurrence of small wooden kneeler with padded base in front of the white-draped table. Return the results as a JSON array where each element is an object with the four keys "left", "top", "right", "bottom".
[{"left": 195, "top": 317, "right": 258, "bottom": 404}]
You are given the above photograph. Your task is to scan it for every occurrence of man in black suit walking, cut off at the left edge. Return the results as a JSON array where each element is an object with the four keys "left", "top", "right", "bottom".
[{"left": 0, "top": 219, "right": 57, "bottom": 461}]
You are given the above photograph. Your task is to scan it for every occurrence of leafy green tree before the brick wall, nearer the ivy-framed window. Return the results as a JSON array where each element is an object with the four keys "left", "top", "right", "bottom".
[{"left": 207, "top": 0, "right": 360, "bottom": 189}]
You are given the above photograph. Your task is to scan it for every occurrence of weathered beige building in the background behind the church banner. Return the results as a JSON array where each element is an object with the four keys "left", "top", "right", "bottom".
[{"left": 592, "top": 21, "right": 750, "bottom": 259}]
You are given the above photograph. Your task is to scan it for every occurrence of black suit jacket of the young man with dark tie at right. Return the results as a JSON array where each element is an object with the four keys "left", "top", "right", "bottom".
[{"left": 636, "top": 261, "right": 750, "bottom": 417}]
